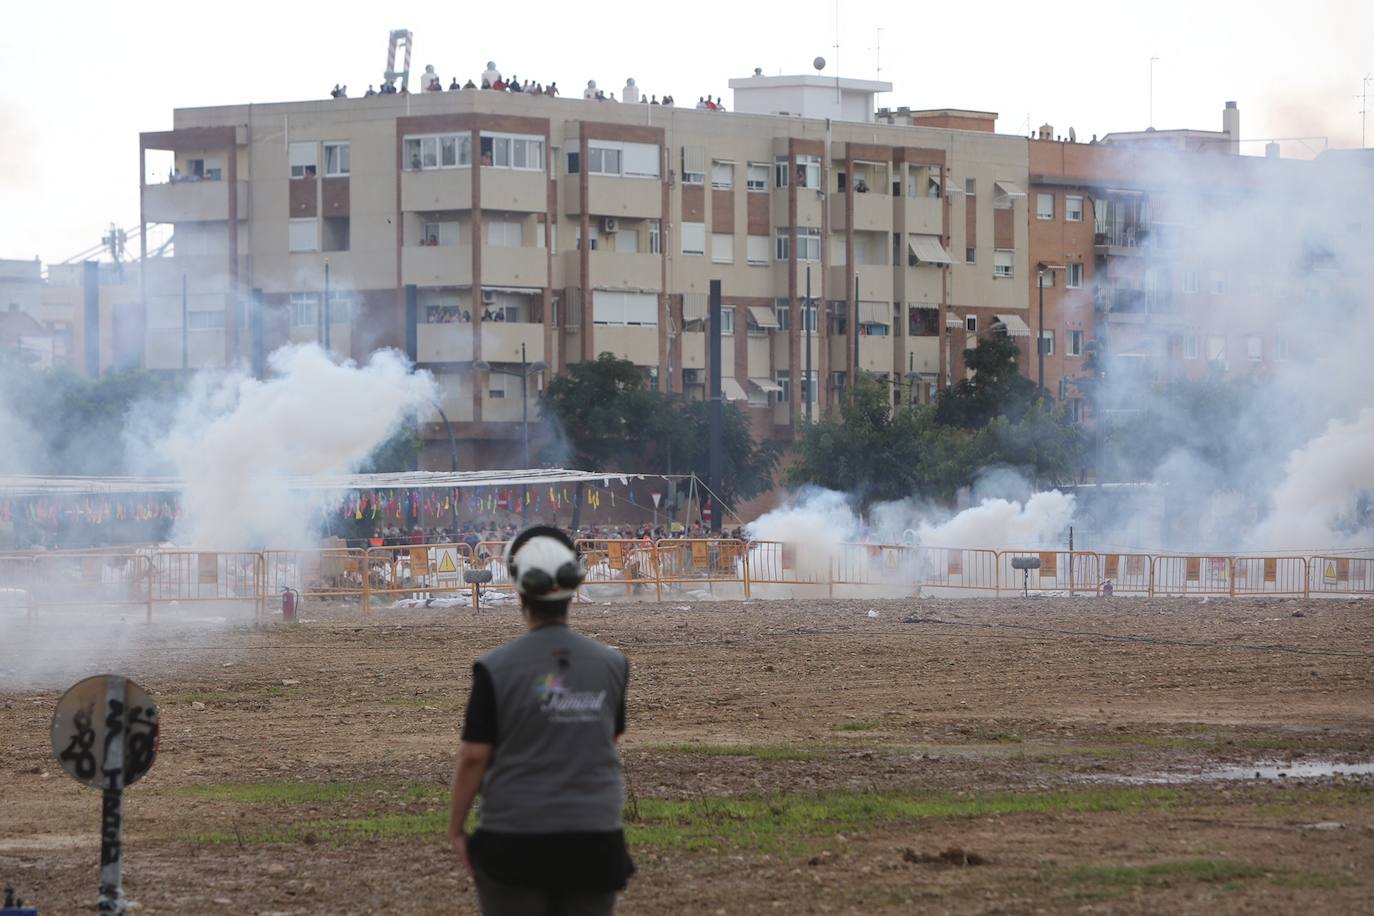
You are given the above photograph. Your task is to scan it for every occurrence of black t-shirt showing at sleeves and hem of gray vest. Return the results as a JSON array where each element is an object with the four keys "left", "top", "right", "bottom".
[{"left": 463, "top": 662, "right": 635, "bottom": 894}]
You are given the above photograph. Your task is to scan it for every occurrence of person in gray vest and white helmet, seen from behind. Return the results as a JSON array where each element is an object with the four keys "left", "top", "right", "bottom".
[{"left": 448, "top": 526, "right": 635, "bottom": 916}]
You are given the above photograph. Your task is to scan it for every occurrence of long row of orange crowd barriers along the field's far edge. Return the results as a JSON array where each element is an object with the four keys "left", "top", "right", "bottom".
[{"left": 0, "top": 538, "right": 1374, "bottom": 621}]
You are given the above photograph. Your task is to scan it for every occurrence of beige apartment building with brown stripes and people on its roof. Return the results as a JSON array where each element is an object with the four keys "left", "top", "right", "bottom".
[{"left": 140, "top": 77, "right": 1029, "bottom": 467}]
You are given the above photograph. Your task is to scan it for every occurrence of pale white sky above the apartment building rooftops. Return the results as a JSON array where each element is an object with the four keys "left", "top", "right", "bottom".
[{"left": 0, "top": 0, "right": 1374, "bottom": 262}]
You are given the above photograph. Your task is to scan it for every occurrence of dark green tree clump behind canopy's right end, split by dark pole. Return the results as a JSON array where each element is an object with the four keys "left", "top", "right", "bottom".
[{"left": 540, "top": 353, "right": 778, "bottom": 501}]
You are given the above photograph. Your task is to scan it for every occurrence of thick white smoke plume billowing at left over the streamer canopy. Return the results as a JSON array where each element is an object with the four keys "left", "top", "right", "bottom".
[{"left": 153, "top": 343, "right": 436, "bottom": 549}]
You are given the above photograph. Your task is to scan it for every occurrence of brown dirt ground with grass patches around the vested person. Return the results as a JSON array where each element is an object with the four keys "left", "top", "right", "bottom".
[{"left": 0, "top": 597, "right": 1374, "bottom": 916}]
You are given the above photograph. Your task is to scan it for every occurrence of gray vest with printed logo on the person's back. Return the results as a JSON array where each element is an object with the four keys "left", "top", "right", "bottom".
[{"left": 478, "top": 626, "right": 629, "bottom": 834}]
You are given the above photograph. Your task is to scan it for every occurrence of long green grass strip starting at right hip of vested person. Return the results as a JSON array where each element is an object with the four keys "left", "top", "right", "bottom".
[{"left": 625, "top": 787, "right": 1182, "bottom": 853}]
